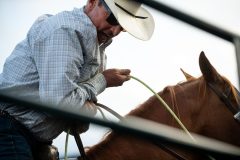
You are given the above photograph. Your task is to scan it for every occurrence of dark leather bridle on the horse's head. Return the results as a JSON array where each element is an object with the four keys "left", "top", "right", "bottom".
[{"left": 207, "top": 82, "right": 240, "bottom": 123}]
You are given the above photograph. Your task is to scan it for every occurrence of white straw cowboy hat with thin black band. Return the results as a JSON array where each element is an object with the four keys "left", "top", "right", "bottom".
[{"left": 104, "top": 0, "right": 155, "bottom": 40}]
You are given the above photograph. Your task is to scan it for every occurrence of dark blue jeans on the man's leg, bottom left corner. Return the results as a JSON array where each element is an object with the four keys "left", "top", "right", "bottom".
[{"left": 0, "top": 116, "right": 33, "bottom": 160}]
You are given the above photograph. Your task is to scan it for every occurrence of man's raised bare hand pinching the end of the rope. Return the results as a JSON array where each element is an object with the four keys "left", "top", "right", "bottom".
[{"left": 102, "top": 69, "right": 131, "bottom": 87}]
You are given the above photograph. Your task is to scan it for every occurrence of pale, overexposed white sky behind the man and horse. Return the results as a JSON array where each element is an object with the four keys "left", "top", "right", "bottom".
[{"left": 0, "top": 0, "right": 240, "bottom": 156}]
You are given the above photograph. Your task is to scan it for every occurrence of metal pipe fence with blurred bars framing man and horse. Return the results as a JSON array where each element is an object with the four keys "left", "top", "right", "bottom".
[{"left": 0, "top": 0, "right": 240, "bottom": 159}]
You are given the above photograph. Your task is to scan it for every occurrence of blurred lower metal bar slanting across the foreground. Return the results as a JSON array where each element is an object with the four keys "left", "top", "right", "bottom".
[{"left": 0, "top": 92, "right": 240, "bottom": 158}]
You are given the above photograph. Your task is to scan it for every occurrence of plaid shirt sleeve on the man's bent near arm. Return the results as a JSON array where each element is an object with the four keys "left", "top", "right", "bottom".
[{"left": 31, "top": 28, "right": 106, "bottom": 108}]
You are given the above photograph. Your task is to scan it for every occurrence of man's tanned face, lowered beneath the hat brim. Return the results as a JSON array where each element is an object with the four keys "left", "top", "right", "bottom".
[{"left": 87, "top": 0, "right": 123, "bottom": 44}]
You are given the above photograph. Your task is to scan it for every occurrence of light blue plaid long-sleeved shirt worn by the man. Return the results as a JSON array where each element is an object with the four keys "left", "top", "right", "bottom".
[{"left": 0, "top": 8, "right": 109, "bottom": 141}]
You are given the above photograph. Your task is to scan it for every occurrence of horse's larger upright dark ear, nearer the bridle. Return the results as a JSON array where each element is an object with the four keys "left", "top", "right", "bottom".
[{"left": 199, "top": 52, "right": 221, "bottom": 82}]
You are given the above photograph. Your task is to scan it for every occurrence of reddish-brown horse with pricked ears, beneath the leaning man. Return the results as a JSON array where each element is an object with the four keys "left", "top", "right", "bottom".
[{"left": 84, "top": 52, "right": 240, "bottom": 160}]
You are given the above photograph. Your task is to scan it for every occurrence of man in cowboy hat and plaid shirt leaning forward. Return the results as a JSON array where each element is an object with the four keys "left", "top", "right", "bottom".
[{"left": 0, "top": 0, "right": 154, "bottom": 160}]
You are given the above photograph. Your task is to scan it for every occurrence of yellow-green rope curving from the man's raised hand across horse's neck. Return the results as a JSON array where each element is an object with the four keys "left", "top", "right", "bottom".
[{"left": 130, "top": 75, "right": 195, "bottom": 142}]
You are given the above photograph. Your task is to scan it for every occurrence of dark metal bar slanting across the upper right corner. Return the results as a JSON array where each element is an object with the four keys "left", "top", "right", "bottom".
[{"left": 135, "top": 0, "right": 239, "bottom": 42}]
